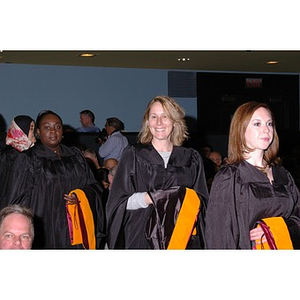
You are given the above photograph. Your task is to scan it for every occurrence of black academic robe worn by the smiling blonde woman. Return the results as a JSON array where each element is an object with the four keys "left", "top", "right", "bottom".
[{"left": 106, "top": 144, "right": 208, "bottom": 249}]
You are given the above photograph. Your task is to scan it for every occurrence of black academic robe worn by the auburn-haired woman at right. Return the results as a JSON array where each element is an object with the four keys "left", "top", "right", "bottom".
[{"left": 205, "top": 161, "right": 300, "bottom": 249}]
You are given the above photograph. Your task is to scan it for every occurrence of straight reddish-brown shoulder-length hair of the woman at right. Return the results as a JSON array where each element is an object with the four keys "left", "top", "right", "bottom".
[{"left": 226, "top": 101, "right": 280, "bottom": 165}]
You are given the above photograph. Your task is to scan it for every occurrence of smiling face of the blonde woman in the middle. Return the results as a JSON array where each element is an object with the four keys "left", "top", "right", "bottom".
[{"left": 148, "top": 102, "right": 174, "bottom": 141}]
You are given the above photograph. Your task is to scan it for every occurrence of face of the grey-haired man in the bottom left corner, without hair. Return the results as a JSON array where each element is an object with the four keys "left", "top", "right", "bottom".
[{"left": 0, "top": 213, "right": 33, "bottom": 249}]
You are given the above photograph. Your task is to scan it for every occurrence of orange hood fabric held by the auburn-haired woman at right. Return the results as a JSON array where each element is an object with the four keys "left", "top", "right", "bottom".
[{"left": 255, "top": 217, "right": 294, "bottom": 250}]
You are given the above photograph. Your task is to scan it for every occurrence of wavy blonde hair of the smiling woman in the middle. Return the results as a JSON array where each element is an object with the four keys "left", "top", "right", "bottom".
[{"left": 138, "top": 96, "right": 188, "bottom": 146}]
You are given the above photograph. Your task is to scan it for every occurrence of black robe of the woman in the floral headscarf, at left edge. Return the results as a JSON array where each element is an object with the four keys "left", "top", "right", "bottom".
[{"left": 0, "top": 145, "right": 20, "bottom": 209}]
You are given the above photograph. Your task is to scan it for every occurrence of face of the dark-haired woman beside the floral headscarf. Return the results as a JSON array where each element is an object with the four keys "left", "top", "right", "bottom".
[{"left": 37, "top": 114, "right": 63, "bottom": 149}]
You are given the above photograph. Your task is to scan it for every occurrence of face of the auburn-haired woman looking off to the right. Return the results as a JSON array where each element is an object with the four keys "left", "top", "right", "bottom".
[{"left": 245, "top": 107, "right": 274, "bottom": 151}]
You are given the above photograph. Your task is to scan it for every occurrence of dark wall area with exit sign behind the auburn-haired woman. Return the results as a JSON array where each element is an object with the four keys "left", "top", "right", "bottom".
[{"left": 197, "top": 72, "right": 300, "bottom": 157}]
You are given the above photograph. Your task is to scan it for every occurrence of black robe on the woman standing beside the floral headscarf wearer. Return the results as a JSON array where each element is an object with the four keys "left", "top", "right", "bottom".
[{"left": 8, "top": 143, "right": 105, "bottom": 249}]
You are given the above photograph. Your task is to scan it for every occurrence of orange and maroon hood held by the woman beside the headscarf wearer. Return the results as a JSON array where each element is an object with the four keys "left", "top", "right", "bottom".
[{"left": 66, "top": 189, "right": 96, "bottom": 249}]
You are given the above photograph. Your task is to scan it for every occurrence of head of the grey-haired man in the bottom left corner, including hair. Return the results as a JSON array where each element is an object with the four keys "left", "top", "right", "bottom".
[{"left": 0, "top": 205, "right": 34, "bottom": 250}]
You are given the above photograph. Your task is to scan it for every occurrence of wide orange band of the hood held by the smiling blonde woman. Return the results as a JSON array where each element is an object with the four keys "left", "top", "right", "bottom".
[{"left": 168, "top": 188, "right": 201, "bottom": 250}]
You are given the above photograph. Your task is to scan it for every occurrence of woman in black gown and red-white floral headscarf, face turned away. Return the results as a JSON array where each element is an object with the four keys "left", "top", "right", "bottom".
[{"left": 0, "top": 115, "right": 36, "bottom": 209}]
